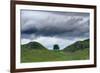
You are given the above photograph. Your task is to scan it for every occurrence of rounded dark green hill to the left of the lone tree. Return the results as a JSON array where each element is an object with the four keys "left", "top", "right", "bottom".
[{"left": 21, "top": 42, "right": 47, "bottom": 50}]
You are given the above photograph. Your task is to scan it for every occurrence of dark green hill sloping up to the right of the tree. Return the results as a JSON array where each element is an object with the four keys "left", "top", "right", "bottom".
[{"left": 64, "top": 39, "right": 89, "bottom": 52}]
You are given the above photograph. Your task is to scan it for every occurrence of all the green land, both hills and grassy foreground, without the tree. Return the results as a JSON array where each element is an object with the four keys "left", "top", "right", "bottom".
[{"left": 21, "top": 39, "right": 89, "bottom": 63}]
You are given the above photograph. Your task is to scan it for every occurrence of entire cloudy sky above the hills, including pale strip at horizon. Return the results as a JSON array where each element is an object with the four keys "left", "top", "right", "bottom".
[{"left": 21, "top": 10, "right": 90, "bottom": 49}]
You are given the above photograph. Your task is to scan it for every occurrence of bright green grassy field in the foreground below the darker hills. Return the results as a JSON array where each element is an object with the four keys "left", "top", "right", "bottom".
[{"left": 21, "top": 47, "right": 89, "bottom": 63}]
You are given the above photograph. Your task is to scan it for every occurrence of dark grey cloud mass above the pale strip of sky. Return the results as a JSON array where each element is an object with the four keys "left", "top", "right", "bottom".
[{"left": 21, "top": 10, "right": 90, "bottom": 39}]
